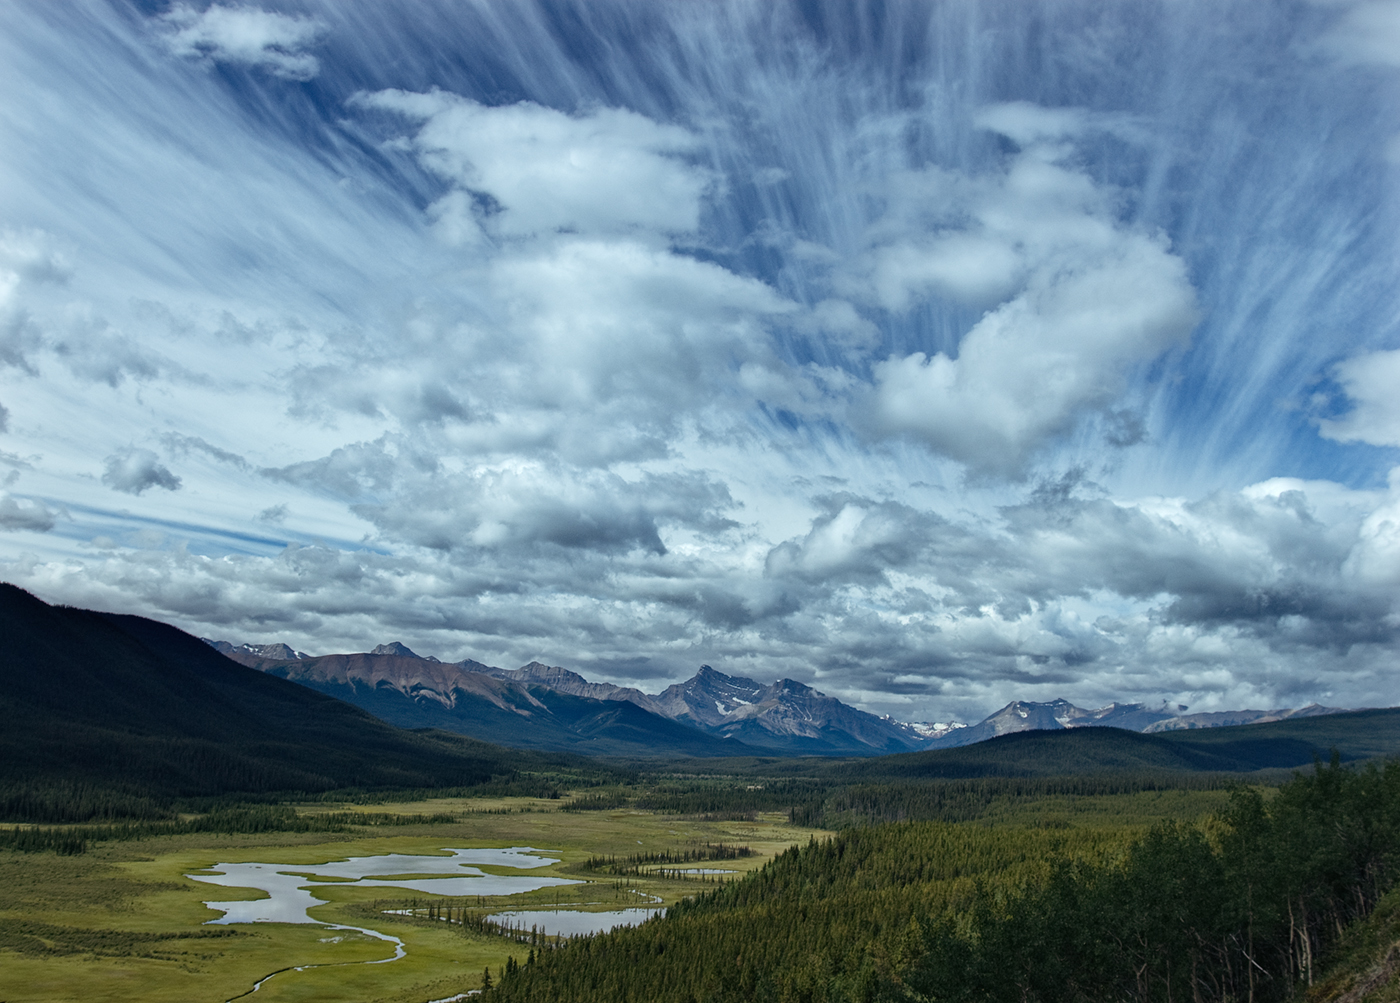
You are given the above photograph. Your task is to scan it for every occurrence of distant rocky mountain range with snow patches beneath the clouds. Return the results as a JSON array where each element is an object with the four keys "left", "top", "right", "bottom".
[{"left": 206, "top": 639, "right": 1338, "bottom": 756}]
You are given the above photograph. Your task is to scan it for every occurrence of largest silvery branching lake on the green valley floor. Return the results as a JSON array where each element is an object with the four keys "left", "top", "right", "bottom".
[{"left": 185, "top": 846, "right": 580, "bottom": 926}]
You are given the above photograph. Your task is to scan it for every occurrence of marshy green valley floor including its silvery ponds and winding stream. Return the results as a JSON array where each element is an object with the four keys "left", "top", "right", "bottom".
[{"left": 0, "top": 797, "right": 813, "bottom": 1003}]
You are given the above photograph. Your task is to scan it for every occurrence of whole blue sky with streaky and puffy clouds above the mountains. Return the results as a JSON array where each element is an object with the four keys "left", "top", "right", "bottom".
[{"left": 0, "top": 0, "right": 1400, "bottom": 720}]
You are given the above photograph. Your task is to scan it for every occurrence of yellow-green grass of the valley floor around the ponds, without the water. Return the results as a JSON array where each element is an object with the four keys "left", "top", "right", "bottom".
[{"left": 0, "top": 798, "right": 813, "bottom": 1003}]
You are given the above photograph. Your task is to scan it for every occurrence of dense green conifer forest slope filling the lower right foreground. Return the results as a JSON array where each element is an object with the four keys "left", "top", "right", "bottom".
[{"left": 490, "top": 761, "right": 1400, "bottom": 1003}]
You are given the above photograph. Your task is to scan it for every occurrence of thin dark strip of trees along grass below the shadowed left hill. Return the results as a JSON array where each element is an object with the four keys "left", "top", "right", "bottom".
[{"left": 0, "top": 804, "right": 456, "bottom": 856}]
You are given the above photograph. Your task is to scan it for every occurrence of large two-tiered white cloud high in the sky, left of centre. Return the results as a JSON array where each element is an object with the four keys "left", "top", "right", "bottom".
[{"left": 322, "top": 91, "right": 795, "bottom": 466}]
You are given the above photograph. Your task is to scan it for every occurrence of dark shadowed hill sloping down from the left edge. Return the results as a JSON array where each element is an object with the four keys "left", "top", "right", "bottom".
[{"left": 0, "top": 584, "right": 579, "bottom": 800}]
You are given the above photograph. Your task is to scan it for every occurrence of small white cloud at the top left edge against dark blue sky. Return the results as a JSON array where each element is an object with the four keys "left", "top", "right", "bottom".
[{"left": 158, "top": 3, "right": 323, "bottom": 80}]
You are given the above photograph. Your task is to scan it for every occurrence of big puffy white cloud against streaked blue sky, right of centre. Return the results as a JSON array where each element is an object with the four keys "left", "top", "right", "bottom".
[{"left": 865, "top": 105, "right": 1197, "bottom": 475}]
